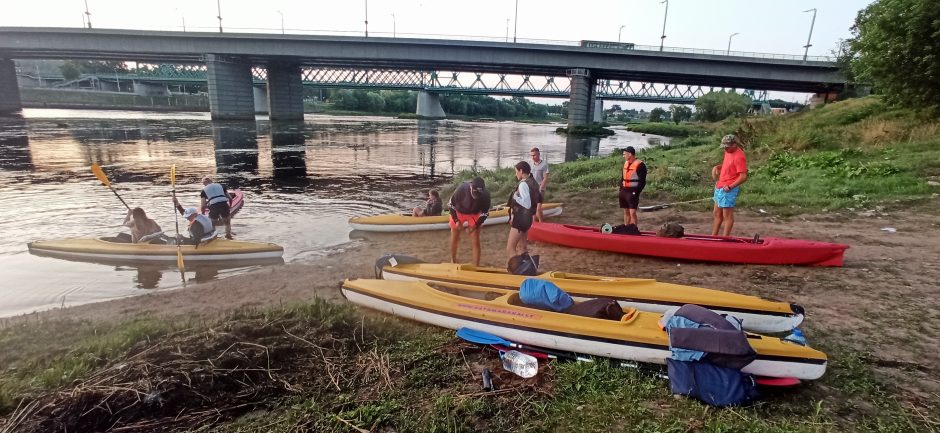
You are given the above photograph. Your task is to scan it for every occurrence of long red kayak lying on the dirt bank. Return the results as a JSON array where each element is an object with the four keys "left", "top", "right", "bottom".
[{"left": 529, "top": 223, "right": 849, "bottom": 266}]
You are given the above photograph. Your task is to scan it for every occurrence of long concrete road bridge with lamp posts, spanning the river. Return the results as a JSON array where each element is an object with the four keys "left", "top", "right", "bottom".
[{"left": 0, "top": 27, "right": 845, "bottom": 121}]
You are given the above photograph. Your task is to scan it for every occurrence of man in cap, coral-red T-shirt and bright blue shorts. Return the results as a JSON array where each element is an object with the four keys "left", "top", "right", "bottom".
[{"left": 712, "top": 134, "right": 747, "bottom": 236}]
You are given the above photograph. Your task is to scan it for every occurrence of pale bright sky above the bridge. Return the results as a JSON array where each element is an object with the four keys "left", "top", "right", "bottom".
[{"left": 0, "top": 0, "right": 872, "bottom": 107}]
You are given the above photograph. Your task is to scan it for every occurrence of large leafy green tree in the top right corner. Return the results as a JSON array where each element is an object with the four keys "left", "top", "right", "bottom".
[{"left": 846, "top": 0, "right": 940, "bottom": 115}]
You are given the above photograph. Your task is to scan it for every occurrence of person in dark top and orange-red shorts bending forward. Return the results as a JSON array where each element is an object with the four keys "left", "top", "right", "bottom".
[{"left": 447, "top": 177, "right": 490, "bottom": 266}]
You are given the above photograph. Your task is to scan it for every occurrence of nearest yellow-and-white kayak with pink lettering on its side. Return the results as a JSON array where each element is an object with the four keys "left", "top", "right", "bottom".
[{"left": 342, "top": 280, "right": 827, "bottom": 380}]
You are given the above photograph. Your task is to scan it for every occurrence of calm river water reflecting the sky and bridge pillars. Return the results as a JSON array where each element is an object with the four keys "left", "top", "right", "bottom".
[{"left": 0, "top": 109, "right": 659, "bottom": 317}]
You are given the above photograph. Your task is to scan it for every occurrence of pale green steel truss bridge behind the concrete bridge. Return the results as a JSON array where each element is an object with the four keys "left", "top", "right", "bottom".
[{"left": 95, "top": 64, "right": 767, "bottom": 104}]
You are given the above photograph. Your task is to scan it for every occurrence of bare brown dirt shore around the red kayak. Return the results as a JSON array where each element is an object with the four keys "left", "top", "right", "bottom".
[{"left": 7, "top": 205, "right": 940, "bottom": 400}]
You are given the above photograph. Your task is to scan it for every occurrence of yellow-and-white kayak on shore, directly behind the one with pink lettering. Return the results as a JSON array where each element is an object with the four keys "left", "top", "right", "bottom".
[{"left": 376, "top": 258, "right": 804, "bottom": 333}]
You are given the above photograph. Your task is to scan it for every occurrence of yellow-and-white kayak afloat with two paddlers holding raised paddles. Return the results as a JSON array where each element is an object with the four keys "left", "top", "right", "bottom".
[{"left": 28, "top": 237, "right": 284, "bottom": 262}]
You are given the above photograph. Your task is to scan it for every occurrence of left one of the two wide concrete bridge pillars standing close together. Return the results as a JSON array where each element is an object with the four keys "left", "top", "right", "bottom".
[{"left": 206, "top": 54, "right": 255, "bottom": 120}]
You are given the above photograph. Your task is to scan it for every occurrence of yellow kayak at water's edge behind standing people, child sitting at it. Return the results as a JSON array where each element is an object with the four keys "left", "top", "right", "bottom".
[{"left": 349, "top": 203, "right": 562, "bottom": 232}]
